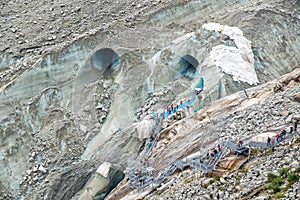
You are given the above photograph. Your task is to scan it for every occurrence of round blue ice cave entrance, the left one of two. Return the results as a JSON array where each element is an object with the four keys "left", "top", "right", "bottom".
[{"left": 92, "top": 48, "right": 121, "bottom": 72}]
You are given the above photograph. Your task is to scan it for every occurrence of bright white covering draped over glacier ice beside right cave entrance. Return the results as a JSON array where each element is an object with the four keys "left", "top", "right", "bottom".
[{"left": 202, "top": 23, "right": 259, "bottom": 85}]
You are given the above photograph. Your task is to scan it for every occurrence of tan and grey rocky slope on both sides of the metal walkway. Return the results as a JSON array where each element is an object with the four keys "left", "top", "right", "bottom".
[{"left": 106, "top": 69, "right": 300, "bottom": 199}]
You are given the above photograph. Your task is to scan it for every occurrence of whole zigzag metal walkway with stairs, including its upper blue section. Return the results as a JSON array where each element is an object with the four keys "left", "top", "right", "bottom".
[{"left": 126, "top": 90, "right": 298, "bottom": 189}]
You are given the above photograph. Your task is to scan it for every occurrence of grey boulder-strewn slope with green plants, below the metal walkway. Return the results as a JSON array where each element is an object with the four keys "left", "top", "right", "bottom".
[{"left": 145, "top": 141, "right": 300, "bottom": 200}]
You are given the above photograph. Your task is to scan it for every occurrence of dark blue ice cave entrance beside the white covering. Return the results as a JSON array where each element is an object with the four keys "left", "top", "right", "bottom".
[{"left": 179, "top": 55, "right": 199, "bottom": 79}]
